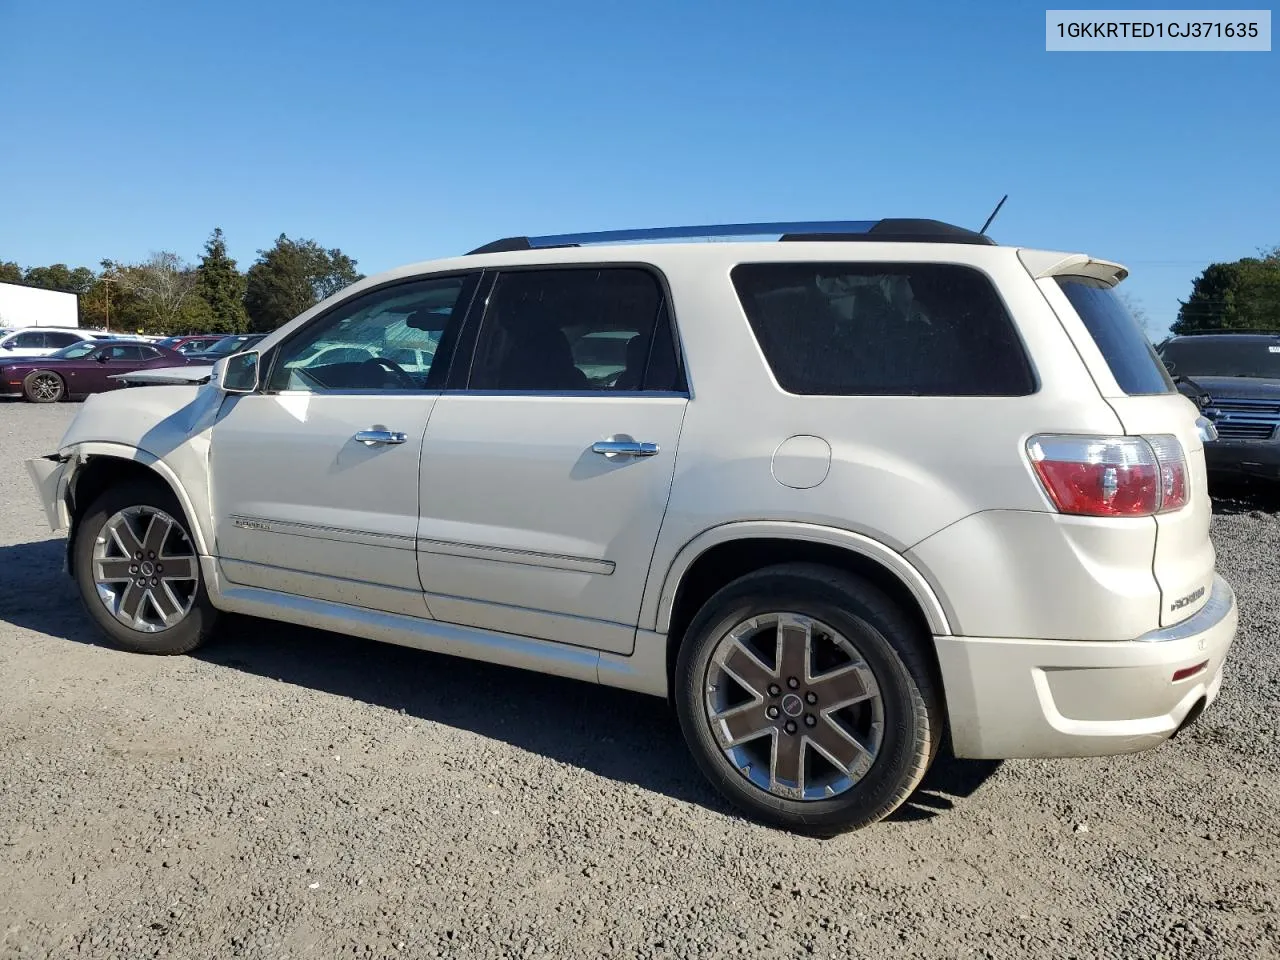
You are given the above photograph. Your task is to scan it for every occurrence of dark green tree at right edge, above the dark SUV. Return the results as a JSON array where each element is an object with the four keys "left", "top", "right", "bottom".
[{"left": 1172, "top": 247, "right": 1280, "bottom": 334}]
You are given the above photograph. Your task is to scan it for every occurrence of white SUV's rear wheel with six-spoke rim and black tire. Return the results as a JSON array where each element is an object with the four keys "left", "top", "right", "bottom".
[{"left": 675, "top": 563, "right": 942, "bottom": 836}]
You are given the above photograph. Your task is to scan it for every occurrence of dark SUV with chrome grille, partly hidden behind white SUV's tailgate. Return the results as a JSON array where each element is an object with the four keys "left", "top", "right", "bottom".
[{"left": 1158, "top": 333, "right": 1280, "bottom": 480}]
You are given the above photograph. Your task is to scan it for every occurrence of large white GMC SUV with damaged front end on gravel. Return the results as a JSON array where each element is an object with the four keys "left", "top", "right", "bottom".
[{"left": 29, "top": 220, "right": 1236, "bottom": 833}]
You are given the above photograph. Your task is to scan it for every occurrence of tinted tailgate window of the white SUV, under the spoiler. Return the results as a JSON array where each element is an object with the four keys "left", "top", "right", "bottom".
[{"left": 1056, "top": 276, "right": 1175, "bottom": 397}]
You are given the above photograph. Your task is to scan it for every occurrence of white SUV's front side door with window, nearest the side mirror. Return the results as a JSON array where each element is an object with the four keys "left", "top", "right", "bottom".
[{"left": 210, "top": 274, "right": 475, "bottom": 617}]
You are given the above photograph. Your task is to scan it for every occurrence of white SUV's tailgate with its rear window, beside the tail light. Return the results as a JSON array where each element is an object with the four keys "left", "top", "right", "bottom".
[{"left": 1038, "top": 261, "right": 1215, "bottom": 626}]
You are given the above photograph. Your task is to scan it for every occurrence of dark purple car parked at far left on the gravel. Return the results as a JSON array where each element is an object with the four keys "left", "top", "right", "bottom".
[{"left": 0, "top": 340, "right": 191, "bottom": 403}]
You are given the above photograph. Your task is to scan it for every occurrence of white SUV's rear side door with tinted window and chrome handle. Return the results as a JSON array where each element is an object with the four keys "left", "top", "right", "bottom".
[{"left": 417, "top": 266, "right": 687, "bottom": 653}]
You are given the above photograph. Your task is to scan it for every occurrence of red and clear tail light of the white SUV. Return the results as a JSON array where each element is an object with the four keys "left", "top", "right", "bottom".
[{"left": 1027, "top": 434, "right": 1189, "bottom": 517}]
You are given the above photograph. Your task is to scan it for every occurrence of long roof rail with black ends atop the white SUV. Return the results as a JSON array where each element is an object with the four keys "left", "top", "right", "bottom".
[{"left": 468, "top": 219, "right": 995, "bottom": 256}]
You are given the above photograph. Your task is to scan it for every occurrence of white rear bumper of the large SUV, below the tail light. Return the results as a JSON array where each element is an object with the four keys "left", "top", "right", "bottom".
[{"left": 934, "top": 576, "right": 1239, "bottom": 759}]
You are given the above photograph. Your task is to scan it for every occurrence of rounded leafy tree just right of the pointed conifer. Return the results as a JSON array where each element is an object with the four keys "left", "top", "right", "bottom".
[{"left": 244, "top": 233, "right": 362, "bottom": 333}]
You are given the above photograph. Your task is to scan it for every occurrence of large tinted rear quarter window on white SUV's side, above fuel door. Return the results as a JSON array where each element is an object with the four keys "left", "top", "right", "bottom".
[{"left": 731, "top": 262, "right": 1036, "bottom": 397}]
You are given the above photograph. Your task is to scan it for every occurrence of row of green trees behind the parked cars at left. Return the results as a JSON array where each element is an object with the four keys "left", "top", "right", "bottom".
[{"left": 0, "top": 228, "right": 364, "bottom": 334}]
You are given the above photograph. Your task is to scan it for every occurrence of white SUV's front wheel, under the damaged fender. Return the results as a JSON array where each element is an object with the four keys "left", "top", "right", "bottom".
[{"left": 72, "top": 480, "right": 218, "bottom": 654}]
